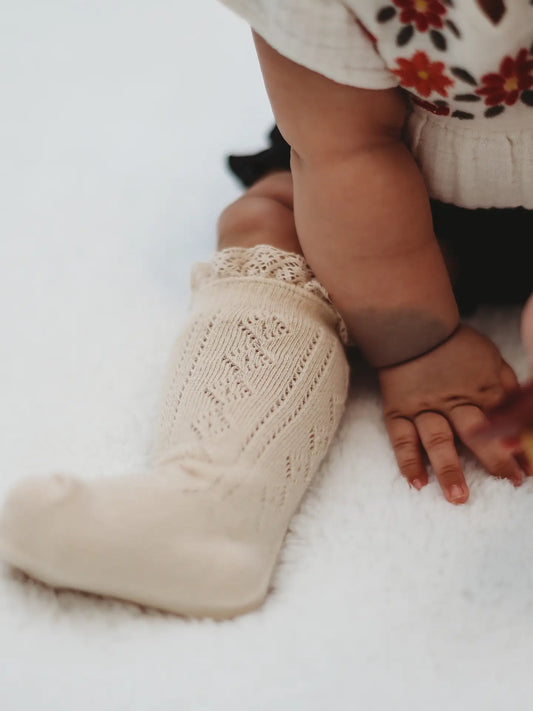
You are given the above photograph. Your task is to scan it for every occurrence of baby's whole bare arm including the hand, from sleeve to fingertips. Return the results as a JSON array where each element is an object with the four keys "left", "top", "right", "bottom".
[{"left": 254, "top": 35, "right": 523, "bottom": 503}]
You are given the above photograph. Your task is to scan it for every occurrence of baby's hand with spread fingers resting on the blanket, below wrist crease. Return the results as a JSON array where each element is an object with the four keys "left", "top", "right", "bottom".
[{"left": 379, "top": 325, "right": 529, "bottom": 504}]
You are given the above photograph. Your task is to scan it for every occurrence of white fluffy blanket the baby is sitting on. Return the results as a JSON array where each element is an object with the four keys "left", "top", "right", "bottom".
[{"left": 0, "top": 0, "right": 533, "bottom": 711}]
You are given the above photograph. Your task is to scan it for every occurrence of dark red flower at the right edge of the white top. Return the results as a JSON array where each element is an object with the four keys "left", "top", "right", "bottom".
[{"left": 476, "top": 49, "right": 533, "bottom": 106}]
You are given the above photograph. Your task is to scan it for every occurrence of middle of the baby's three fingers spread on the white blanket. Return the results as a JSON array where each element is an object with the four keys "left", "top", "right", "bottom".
[{"left": 415, "top": 412, "right": 469, "bottom": 504}]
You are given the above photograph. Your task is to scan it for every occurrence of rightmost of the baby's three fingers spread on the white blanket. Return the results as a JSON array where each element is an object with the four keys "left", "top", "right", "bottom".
[{"left": 450, "top": 405, "right": 524, "bottom": 486}]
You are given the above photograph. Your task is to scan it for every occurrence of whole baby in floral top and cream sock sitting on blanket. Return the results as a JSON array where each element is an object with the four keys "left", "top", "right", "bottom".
[{"left": 0, "top": 0, "right": 533, "bottom": 618}]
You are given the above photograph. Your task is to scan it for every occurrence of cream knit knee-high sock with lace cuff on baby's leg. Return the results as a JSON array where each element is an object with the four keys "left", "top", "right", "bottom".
[{"left": 0, "top": 245, "right": 348, "bottom": 618}]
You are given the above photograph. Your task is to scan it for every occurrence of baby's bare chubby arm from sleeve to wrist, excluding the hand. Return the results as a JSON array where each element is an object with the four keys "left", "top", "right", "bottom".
[{"left": 251, "top": 35, "right": 459, "bottom": 367}]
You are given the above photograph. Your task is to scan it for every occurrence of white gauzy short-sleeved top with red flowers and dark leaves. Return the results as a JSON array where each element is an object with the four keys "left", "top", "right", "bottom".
[{"left": 216, "top": 0, "right": 533, "bottom": 209}]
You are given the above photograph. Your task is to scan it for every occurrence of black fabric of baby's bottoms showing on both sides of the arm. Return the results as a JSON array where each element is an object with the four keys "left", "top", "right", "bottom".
[{"left": 228, "top": 126, "right": 533, "bottom": 316}]
